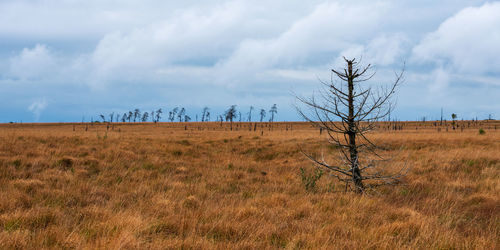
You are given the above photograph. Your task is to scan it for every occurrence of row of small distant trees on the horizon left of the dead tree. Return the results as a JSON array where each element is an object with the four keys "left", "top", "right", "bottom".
[{"left": 92, "top": 104, "right": 278, "bottom": 123}]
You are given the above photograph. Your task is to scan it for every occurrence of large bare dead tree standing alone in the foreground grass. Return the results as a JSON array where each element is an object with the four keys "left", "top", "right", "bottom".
[{"left": 296, "top": 58, "right": 405, "bottom": 193}]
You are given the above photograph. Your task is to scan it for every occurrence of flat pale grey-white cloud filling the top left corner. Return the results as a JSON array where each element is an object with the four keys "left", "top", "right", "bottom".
[{"left": 0, "top": 0, "right": 220, "bottom": 40}]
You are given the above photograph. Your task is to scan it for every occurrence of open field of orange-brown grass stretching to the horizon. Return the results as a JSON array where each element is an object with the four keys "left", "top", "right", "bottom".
[{"left": 0, "top": 121, "right": 500, "bottom": 249}]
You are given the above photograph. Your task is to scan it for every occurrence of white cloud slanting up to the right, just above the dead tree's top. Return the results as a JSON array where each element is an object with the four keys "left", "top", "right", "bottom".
[{"left": 219, "top": 2, "right": 388, "bottom": 69}]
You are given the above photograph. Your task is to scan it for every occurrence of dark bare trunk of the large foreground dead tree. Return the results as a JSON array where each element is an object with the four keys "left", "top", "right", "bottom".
[{"left": 347, "top": 61, "right": 364, "bottom": 193}]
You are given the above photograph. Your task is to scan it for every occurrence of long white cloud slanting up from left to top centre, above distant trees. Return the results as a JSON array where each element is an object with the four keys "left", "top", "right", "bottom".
[{"left": 90, "top": 1, "right": 307, "bottom": 86}]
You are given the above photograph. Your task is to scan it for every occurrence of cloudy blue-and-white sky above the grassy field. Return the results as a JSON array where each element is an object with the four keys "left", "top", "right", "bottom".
[{"left": 0, "top": 0, "right": 500, "bottom": 122}]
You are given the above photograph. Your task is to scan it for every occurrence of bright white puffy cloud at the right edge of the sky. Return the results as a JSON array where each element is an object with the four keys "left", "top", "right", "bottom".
[{"left": 413, "top": 2, "right": 500, "bottom": 74}]
